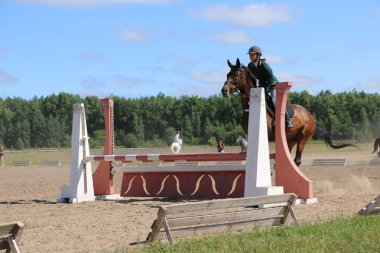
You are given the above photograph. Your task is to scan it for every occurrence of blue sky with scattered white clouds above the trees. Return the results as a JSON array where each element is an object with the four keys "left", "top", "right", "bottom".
[{"left": 0, "top": 0, "right": 380, "bottom": 99}]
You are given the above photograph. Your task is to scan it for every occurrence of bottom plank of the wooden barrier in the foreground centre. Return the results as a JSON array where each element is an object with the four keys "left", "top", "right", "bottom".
[{"left": 157, "top": 216, "right": 282, "bottom": 239}]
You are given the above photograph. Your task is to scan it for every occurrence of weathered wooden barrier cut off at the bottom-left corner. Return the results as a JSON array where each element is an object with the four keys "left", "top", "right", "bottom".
[{"left": 0, "top": 222, "right": 24, "bottom": 253}]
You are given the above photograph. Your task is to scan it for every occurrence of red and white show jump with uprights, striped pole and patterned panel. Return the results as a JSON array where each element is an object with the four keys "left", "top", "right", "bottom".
[{"left": 58, "top": 83, "right": 313, "bottom": 203}]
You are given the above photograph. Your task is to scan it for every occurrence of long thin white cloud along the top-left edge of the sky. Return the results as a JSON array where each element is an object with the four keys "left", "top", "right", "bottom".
[{"left": 7, "top": 0, "right": 179, "bottom": 7}]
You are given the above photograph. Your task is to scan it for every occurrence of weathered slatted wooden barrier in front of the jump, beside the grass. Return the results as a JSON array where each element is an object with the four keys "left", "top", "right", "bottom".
[{"left": 146, "top": 194, "right": 297, "bottom": 243}]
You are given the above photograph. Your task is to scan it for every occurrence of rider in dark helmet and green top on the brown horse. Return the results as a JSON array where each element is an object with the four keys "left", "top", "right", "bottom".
[{"left": 247, "top": 46, "right": 293, "bottom": 128}]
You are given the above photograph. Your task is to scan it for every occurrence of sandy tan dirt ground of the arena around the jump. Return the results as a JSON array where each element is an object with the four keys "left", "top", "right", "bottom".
[{"left": 0, "top": 148, "right": 380, "bottom": 252}]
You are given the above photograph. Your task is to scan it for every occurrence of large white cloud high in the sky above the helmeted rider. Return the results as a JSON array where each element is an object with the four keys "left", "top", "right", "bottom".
[{"left": 201, "top": 4, "right": 295, "bottom": 26}]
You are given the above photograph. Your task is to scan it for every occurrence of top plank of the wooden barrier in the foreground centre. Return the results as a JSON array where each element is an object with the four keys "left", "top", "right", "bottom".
[{"left": 162, "top": 193, "right": 294, "bottom": 215}]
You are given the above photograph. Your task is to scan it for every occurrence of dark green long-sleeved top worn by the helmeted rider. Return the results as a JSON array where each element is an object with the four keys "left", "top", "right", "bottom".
[{"left": 248, "top": 59, "right": 278, "bottom": 93}]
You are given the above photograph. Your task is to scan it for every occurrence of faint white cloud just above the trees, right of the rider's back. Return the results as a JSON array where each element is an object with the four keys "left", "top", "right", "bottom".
[{"left": 276, "top": 72, "right": 323, "bottom": 90}]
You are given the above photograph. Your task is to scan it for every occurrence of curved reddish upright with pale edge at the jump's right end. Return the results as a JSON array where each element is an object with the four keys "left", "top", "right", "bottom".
[{"left": 275, "top": 82, "right": 317, "bottom": 204}]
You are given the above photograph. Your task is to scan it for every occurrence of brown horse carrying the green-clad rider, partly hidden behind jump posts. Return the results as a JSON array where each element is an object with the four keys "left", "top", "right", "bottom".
[{"left": 222, "top": 59, "right": 355, "bottom": 166}]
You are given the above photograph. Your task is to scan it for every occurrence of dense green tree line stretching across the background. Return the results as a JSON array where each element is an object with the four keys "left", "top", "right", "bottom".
[{"left": 0, "top": 90, "right": 380, "bottom": 149}]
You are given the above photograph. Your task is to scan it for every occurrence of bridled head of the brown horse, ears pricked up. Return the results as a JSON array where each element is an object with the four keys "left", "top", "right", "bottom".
[{"left": 222, "top": 58, "right": 256, "bottom": 97}]
